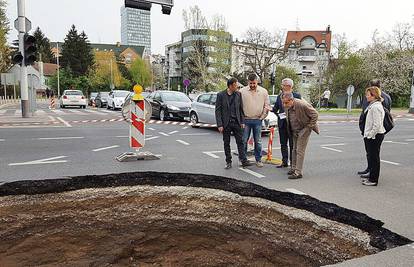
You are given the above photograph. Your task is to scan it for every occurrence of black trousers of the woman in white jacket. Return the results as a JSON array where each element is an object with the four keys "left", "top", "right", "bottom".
[{"left": 364, "top": 134, "right": 384, "bottom": 183}]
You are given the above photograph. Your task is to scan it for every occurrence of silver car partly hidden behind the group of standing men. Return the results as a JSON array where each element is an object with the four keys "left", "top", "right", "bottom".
[{"left": 190, "top": 92, "right": 277, "bottom": 132}]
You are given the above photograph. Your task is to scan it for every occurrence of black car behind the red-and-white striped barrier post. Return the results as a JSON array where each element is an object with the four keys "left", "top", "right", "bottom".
[{"left": 146, "top": 91, "right": 191, "bottom": 121}]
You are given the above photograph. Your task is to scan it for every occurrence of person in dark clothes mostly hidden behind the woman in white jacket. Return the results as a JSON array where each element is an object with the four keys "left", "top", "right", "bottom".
[{"left": 358, "top": 79, "right": 392, "bottom": 178}]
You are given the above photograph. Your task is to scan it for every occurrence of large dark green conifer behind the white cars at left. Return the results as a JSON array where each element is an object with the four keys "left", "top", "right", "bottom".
[{"left": 60, "top": 25, "right": 94, "bottom": 76}]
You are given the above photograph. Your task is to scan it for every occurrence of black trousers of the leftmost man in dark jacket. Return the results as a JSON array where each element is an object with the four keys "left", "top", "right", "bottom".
[{"left": 223, "top": 121, "right": 247, "bottom": 163}]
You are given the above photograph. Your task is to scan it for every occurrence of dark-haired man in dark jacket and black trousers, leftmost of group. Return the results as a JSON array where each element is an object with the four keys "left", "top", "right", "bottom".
[{"left": 216, "top": 78, "right": 251, "bottom": 169}]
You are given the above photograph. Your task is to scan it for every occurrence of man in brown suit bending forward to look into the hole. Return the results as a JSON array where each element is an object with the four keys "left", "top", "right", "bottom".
[{"left": 282, "top": 92, "right": 319, "bottom": 179}]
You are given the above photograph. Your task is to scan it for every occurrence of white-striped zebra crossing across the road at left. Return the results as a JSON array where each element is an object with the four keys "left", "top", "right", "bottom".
[{"left": 0, "top": 109, "right": 121, "bottom": 116}]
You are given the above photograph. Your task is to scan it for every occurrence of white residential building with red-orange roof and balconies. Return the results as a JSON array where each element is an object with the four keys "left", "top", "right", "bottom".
[{"left": 283, "top": 26, "right": 332, "bottom": 91}]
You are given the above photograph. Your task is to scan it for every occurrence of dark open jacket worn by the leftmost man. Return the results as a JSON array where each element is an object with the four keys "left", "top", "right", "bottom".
[{"left": 216, "top": 89, "right": 244, "bottom": 128}]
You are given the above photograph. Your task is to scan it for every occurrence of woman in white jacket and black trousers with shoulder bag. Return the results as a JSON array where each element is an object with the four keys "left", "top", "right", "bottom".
[{"left": 361, "top": 86, "right": 385, "bottom": 186}]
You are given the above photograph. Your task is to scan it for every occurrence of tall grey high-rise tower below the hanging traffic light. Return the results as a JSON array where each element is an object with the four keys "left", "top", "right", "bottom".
[{"left": 121, "top": 6, "right": 151, "bottom": 56}]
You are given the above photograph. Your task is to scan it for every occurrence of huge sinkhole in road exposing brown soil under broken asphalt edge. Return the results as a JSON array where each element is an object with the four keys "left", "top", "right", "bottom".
[{"left": 0, "top": 172, "right": 411, "bottom": 266}]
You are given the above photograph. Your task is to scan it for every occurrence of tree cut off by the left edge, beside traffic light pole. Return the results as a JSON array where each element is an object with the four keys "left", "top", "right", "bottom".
[{"left": 0, "top": 0, "right": 10, "bottom": 72}]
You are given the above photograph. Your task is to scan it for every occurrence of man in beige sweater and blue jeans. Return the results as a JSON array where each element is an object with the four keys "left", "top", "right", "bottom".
[{"left": 240, "top": 73, "right": 271, "bottom": 167}]
